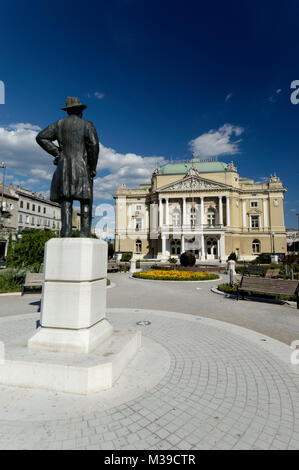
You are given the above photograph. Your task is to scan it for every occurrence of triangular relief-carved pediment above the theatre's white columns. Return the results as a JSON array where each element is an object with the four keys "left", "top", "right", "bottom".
[{"left": 158, "top": 168, "right": 231, "bottom": 192}]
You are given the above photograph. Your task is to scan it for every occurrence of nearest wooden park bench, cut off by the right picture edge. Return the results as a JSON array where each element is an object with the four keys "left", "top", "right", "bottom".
[{"left": 237, "top": 276, "right": 299, "bottom": 309}]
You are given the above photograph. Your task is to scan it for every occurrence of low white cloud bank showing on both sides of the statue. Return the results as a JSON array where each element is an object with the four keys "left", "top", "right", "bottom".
[{"left": 0, "top": 123, "right": 167, "bottom": 199}]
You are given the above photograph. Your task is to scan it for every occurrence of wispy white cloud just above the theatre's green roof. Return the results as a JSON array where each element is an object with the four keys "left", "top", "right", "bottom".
[{"left": 189, "top": 124, "right": 244, "bottom": 157}]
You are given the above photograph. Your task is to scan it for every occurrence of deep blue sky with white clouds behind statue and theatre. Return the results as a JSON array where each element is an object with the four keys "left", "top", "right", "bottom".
[{"left": 0, "top": 0, "right": 299, "bottom": 227}]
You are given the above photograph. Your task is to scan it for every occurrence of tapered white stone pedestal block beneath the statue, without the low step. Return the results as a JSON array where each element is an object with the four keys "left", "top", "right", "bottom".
[{"left": 28, "top": 238, "right": 112, "bottom": 353}]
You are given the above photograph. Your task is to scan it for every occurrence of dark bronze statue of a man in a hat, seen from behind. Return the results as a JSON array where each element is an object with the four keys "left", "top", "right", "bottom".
[{"left": 36, "top": 97, "right": 99, "bottom": 237}]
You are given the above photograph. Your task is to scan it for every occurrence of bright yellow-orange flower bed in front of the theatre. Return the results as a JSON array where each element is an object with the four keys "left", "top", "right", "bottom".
[{"left": 133, "top": 270, "right": 219, "bottom": 281}]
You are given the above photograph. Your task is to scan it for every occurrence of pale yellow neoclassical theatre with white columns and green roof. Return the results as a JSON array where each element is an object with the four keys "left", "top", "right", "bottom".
[{"left": 114, "top": 158, "right": 286, "bottom": 261}]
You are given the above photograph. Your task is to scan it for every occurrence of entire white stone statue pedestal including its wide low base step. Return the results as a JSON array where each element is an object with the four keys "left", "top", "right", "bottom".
[{"left": 0, "top": 238, "right": 141, "bottom": 394}]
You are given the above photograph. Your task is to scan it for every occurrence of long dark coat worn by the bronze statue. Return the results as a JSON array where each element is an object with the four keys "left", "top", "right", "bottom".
[{"left": 36, "top": 114, "right": 99, "bottom": 203}]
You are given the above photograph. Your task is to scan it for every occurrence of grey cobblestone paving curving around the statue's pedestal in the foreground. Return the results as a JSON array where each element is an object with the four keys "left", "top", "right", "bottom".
[{"left": 0, "top": 309, "right": 299, "bottom": 450}]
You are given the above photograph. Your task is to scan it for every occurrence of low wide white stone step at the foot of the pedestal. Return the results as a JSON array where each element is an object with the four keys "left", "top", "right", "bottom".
[{"left": 0, "top": 330, "right": 141, "bottom": 395}]
